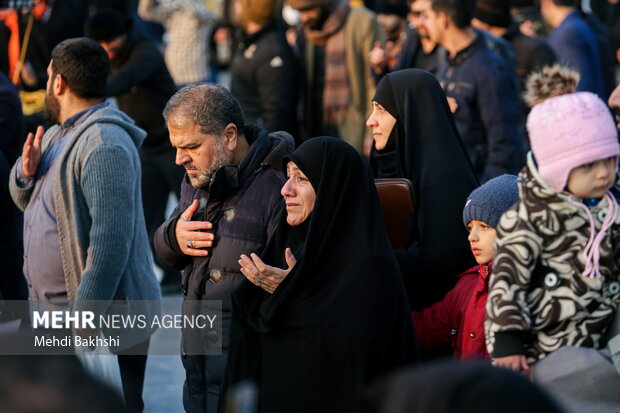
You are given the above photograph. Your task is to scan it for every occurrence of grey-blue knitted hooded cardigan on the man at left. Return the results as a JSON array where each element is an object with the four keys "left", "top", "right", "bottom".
[{"left": 10, "top": 106, "right": 160, "bottom": 348}]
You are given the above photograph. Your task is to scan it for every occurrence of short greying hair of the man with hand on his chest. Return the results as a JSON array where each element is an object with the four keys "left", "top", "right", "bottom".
[{"left": 164, "top": 83, "right": 244, "bottom": 135}]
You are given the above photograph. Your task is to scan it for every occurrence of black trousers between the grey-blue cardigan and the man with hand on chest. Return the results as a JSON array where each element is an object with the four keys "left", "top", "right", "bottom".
[{"left": 140, "top": 141, "right": 185, "bottom": 284}]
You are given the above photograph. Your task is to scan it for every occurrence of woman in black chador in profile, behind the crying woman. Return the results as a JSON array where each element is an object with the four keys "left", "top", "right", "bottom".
[{"left": 366, "top": 69, "right": 478, "bottom": 310}]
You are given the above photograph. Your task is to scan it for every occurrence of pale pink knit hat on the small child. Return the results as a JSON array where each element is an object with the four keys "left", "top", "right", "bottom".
[{"left": 527, "top": 92, "right": 620, "bottom": 192}]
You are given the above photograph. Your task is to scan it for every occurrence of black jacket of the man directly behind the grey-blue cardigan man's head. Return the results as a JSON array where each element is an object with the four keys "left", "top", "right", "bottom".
[{"left": 108, "top": 25, "right": 176, "bottom": 146}]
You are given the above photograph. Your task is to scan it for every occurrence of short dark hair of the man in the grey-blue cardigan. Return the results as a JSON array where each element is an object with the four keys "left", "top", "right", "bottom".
[{"left": 52, "top": 37, "right": 110, "bottom": 99}]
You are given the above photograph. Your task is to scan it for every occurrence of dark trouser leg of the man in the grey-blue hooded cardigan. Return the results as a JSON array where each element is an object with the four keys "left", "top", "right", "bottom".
[{"left": 118, "top": 339, "right": 150, "bottom": 413}]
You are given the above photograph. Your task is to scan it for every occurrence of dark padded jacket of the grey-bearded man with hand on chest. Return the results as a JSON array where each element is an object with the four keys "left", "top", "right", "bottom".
[{"left": 155, "top": 125, "right": 294, "bottom": 412}]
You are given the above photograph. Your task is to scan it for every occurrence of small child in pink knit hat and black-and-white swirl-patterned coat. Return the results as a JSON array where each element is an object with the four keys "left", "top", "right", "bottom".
[{"left": 485, "top": 67, "right": 620, "bottom": 380}]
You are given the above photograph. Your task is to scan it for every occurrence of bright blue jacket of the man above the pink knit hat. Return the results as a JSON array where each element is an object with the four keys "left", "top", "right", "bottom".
[{"left": 548, "top": 11, "right": 607, "bottom": 101}]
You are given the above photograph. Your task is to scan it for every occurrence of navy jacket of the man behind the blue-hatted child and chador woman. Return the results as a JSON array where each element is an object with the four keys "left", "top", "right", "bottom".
[{"left": 437, "top": 36, "right": 524, "bottom": 181}]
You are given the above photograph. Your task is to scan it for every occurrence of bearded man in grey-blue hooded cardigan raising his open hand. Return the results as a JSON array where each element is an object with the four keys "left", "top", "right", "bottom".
[{"left": 9, "top": 38, "right": 160, "bottom": 412}]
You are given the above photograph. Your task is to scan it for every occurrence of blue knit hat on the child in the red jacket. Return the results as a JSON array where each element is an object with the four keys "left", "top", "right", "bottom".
[{"left": 463, "top": 174, "right": 519, "bottom": 228}]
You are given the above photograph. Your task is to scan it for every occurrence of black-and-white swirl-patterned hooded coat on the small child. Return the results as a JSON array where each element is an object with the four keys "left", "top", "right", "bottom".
[{"left": 485, "top": 156, "right": 620, "bottom": 364}]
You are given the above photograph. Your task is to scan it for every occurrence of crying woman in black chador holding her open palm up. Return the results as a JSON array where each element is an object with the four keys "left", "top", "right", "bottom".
[{"left": 220, "top": 137, "right": 418, "bottom": 413}]
